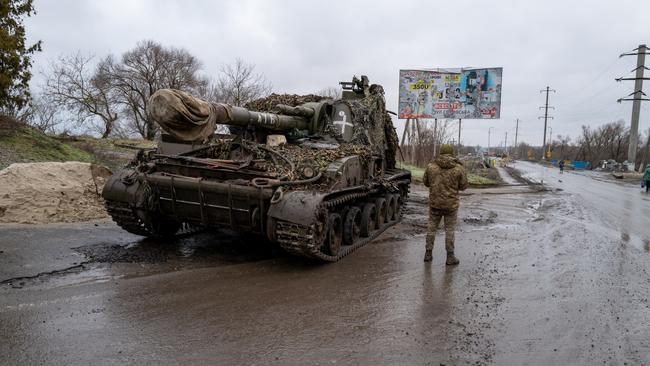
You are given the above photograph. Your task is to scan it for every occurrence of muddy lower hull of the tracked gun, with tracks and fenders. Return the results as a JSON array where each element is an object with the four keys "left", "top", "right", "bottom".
[{"left": 103, "top": 159, "right": 410, "bottom": 262}]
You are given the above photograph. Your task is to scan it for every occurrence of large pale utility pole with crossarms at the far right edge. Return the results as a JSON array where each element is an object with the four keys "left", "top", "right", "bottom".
[{"left": 616, "top": 44, "right": 650, "bottom": 171}]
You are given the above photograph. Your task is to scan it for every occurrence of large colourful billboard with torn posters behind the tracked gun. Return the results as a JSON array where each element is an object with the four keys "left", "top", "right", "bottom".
[{"left": 399, "top": 67, "right": 503, "bottom": 119}]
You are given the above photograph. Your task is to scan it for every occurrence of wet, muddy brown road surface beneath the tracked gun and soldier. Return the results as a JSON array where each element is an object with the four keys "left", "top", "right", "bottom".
[{"left": 0, "top": 163, "right": 650, "bottom": 365}]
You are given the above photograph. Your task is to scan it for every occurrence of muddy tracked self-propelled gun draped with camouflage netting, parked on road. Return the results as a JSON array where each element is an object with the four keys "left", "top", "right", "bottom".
[{"left": 102, "top": 76, "right": 411, "bottom": 262}]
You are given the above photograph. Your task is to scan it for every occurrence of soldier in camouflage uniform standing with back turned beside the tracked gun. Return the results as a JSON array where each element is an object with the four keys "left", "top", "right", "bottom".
[{"left": 422, "top": 145, "right": 468, "bottom": 265}]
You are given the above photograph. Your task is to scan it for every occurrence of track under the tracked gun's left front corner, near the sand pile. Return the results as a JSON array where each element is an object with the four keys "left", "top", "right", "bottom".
[{"left": 104, "top": 200, "right": 203, "bottom": 237}]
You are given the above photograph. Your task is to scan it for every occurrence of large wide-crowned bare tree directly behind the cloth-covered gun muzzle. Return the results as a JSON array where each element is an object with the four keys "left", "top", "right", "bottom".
[{"left": 107, "top": 41, "right": 208, "bottom": 139}]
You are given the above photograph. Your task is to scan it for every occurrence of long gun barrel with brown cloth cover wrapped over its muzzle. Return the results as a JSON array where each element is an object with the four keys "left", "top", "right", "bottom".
[{"left": 147, "top": 89, "right": 322, "bottom": 141}]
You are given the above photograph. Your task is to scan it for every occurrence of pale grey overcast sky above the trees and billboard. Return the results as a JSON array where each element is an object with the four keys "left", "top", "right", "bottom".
[{"left": 26, "top": 0, "right": 650, "bottom": 145}]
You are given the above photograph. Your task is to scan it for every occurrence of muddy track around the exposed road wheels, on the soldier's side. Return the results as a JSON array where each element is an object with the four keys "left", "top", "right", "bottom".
[{"left": 276, "top": 185, "right": 409, "bottom": 262}]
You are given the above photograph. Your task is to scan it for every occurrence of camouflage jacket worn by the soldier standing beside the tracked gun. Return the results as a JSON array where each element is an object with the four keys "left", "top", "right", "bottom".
[{"left": 422, "top": 155, "right": 468, "bottom": 210}]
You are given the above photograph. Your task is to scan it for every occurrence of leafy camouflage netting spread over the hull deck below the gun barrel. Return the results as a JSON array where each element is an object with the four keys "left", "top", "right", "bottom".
[{"left": 195, "top": 140, "right": 372, "bottom": 180}]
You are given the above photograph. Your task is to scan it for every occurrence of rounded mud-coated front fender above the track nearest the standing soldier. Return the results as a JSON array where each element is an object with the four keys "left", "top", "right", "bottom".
[{"left": 268, "top": 191, "right": 325, "bottom": 226}]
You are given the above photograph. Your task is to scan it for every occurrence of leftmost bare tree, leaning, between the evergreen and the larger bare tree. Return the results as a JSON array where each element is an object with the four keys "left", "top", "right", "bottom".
[{"left": 43, "top": 53, "right": 118, "bottom": 138}]
